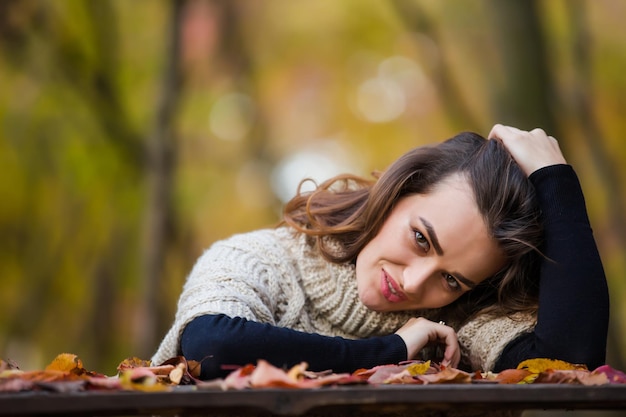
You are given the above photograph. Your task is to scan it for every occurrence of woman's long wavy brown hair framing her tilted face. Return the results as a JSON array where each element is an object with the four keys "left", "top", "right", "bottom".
[{"left": 283, "top": 132, "right": 542, "bottom": 321}]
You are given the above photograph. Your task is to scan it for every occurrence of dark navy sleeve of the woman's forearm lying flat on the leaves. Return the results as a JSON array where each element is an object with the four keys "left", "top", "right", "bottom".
[{"left": 180, "top": 314, "right": 407, "bottom": 379}]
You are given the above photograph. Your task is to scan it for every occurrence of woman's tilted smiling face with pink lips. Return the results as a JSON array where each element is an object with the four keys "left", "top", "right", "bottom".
[{"left": 356, "top": 175, "right": 505, "bottom": 311}]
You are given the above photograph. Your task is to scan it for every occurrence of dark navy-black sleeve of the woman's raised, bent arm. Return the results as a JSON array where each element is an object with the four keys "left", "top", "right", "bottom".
[{"left": 495, "top": 165, "right": 609, "bottom": 372}]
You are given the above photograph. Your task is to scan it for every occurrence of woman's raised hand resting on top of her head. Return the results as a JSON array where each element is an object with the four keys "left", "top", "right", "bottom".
[{"left": 488, "top": 124, "right": 567, "bottom": 175}]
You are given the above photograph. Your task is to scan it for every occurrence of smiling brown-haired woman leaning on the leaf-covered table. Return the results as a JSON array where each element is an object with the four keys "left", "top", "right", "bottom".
[{"left": 153, "top": 125, "right": 608, "bottom": 379}]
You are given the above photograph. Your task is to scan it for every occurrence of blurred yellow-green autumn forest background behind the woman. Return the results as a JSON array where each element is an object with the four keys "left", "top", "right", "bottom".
[{"left": 0, "top": 0, "right": 626, "bottom": 386}]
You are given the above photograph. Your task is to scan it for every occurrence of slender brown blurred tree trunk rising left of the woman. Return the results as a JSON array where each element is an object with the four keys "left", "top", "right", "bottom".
[{"left": 135, "top": 0, "right": 186, "bottom": 358}]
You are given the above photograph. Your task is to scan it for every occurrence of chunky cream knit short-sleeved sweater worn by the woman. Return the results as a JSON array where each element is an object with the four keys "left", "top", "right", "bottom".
[{"left": 152, "top": 227, "right": 534, "bottom": 371}]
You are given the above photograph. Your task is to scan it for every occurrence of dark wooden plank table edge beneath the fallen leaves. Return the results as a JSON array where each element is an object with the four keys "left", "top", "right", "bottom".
[{"left": 0, "top": 384, "right": 626, "bottom": 416}]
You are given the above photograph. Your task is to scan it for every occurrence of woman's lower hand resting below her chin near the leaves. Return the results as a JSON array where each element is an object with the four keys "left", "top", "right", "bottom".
[{"left": 396, "top": 317, "right": 461, "bottom": 368}]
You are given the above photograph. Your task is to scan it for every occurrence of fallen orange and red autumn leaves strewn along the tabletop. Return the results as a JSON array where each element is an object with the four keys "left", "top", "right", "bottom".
[{"left": 0, "top": 353, "right": 626, "bottom": 393}]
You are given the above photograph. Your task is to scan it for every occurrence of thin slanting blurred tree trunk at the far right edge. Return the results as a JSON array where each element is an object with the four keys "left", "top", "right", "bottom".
[{"left": 567, "top": 0, "right": 626, "bottom": 369}]
